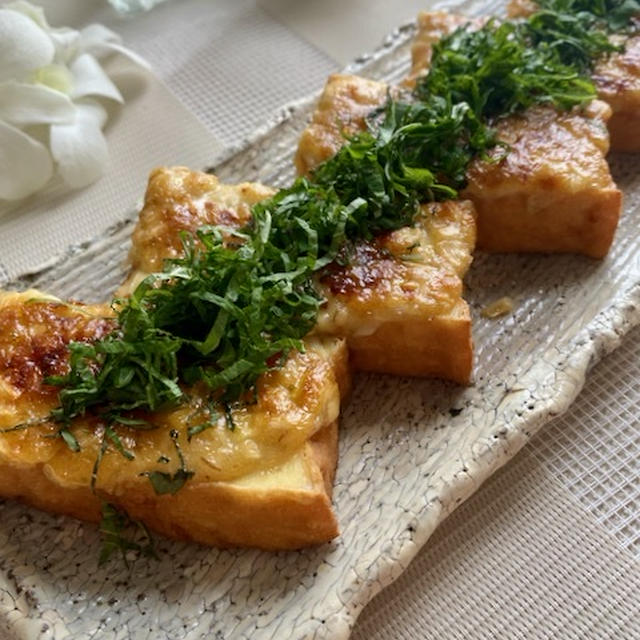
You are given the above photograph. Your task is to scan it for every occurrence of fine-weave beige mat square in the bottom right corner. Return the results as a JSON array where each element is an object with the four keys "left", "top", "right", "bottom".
[{"left": 352, "top": 452, "right": 640, "bottom": 640}]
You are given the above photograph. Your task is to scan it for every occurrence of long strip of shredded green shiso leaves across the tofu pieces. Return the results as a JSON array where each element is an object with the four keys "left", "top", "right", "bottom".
[{"left": 3, "top": 0, "right": 640, "bottom": 557}]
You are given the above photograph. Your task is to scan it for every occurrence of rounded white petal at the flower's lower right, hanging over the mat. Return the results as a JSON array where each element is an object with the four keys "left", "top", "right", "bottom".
[{"left": 51, "top": 102, "right": 109, "bottom": 188}]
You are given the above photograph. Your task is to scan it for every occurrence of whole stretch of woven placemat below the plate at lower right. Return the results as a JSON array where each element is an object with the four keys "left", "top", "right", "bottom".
[{"left": 352, "top": 329, "right": 640, "bottom": 640}]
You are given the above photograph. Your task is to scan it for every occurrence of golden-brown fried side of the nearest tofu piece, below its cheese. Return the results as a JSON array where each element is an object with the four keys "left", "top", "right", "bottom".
[{"left": 0, "top": 422, "right": 339, "bottom": 550}]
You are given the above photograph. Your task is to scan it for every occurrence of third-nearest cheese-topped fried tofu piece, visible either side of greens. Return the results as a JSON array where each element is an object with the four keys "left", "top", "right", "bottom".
[{"left": 412, "top": 12, "right": 622, "bottom": 258}]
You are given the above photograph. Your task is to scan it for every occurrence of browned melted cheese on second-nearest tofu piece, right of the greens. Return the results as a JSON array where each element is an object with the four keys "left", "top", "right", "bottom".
[{"left": 317, "top": 201, "right": 475, "bottom": 337}]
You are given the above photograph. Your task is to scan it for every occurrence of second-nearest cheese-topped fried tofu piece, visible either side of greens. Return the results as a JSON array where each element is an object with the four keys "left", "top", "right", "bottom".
[{"left": 120, "top": 168, "right": 475, "bottom": 383}]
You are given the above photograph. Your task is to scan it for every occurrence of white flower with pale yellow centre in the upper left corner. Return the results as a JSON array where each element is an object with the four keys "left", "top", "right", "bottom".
[{"left": 0, "top": 0, "right": 147, "bottom": 200}]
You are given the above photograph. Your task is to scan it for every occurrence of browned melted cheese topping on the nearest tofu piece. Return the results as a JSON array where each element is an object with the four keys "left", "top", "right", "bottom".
[{"left": 0, "top": 291, "right": 346, "bottom": 491}]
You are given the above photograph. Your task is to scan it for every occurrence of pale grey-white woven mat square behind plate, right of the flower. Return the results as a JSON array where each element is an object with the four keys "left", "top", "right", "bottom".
[{"left": 105, "top": 0, "right": 338, "bottom": 146}]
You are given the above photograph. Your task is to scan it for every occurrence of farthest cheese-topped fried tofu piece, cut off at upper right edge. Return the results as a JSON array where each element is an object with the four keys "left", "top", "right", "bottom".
[{"left": 507, "top": 0, "right": 640, "bottom": 152}]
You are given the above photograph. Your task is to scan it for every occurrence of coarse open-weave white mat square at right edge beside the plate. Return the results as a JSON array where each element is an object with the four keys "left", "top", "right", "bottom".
[{"left": 531, "top": 329, "right": 640, "bottom": 559}]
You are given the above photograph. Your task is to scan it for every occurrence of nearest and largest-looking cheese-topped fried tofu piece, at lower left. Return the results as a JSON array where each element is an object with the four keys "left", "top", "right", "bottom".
[{"left": 0, "top": 291, "right": 349, "bottom": 549}]
